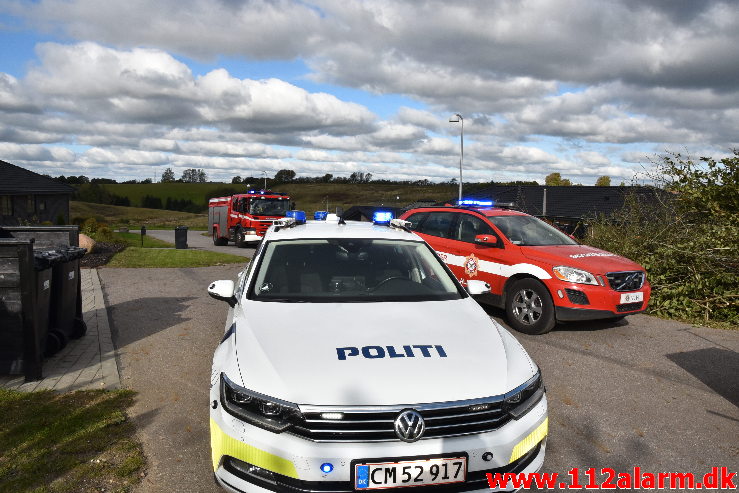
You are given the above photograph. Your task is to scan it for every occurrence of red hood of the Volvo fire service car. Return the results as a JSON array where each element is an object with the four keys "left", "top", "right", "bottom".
[{"left": 521, "top": 245, "right": 644, "bottom": 274}]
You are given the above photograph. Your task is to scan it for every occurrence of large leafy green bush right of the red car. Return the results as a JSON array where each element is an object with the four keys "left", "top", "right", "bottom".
[{"left": 586, "top": 151, "right": 739, "bottom": 326}]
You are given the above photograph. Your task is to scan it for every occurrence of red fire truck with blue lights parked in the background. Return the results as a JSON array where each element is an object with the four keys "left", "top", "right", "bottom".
[{"left": 208, "top": 190, "right": 291, "bottom": 248}]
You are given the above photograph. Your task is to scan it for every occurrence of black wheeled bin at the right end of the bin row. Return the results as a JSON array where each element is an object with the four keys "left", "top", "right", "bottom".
[{"left": 46, "top": 246, "right": 87, "bottom": 355}]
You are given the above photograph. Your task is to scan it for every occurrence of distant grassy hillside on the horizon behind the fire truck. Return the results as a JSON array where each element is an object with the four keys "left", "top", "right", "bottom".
[{"left": 97, "top": 182, "right": 457, "bottom": 214}]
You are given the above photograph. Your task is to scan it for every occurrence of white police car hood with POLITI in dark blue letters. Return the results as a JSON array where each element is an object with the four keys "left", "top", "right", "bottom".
[{"left": 236, "top": 298, "right": 536, "bottom": 406}]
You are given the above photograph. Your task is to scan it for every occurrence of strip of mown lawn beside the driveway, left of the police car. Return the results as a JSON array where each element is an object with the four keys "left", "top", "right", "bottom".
[{"left": 107, "top": 247, "right": 249, "bottom": 268}]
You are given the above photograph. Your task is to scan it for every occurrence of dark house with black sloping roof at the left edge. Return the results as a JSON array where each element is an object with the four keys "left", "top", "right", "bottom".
[{"left": 0, "top": 160, "right": 74, "bottom": 226}]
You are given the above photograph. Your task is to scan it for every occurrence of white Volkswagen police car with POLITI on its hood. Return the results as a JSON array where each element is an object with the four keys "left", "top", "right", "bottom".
[{"left": 208, "top": 212, "right": 548, "bottom": 493}]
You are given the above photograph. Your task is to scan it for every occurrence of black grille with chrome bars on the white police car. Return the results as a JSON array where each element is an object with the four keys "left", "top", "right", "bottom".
[{"left": 290, "top": 404, "right": 510, "bottom": 442}]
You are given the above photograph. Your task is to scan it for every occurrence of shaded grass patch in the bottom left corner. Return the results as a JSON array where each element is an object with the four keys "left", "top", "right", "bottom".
[{"left": 0, "top": 388, "right": 145, "bottom": 493}]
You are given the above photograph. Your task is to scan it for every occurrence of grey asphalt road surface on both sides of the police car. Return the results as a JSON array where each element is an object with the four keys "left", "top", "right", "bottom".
[{"left": 100, "top": 266, "right": 739, "bottom": 493}]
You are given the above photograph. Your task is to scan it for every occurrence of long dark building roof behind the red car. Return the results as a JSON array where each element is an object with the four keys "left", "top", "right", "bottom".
[{"left": 456, "top": 185, "right": 668, "bottom": 218}]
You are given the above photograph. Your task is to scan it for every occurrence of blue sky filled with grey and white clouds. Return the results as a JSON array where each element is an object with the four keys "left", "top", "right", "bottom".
[{"left": 0, "top": 0, "right": 739, "bottom": 184}]
